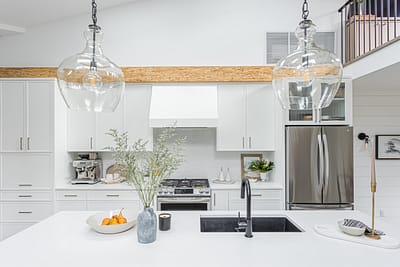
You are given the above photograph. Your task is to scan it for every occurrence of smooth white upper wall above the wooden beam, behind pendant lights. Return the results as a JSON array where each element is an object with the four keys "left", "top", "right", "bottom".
[{"left": 0, "top": 0, "right": 343, "bottom": 66}]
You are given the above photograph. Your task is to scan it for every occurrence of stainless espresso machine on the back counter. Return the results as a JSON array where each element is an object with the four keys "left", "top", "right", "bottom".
[{"left": 71, "top": 155, "right": 103, "bottom": 184}]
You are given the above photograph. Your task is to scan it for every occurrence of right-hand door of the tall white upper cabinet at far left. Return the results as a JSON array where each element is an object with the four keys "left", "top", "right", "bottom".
[{"left": 26, "top": 81, "right": 55, "bottom": 152}]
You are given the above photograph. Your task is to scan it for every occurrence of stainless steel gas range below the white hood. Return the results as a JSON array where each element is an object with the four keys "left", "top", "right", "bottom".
[{"left": 157, "top": 178, "right": 211, "bottom": 213}]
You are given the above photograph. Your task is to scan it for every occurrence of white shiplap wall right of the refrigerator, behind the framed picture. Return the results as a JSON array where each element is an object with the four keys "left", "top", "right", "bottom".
[{"left": 353, "top": 66, "right": 400, "bottom": 223}]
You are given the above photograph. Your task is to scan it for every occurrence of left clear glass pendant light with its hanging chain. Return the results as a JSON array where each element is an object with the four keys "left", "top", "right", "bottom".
[{"left": 57, "top": 0, "right": 125, "bottom": 112}]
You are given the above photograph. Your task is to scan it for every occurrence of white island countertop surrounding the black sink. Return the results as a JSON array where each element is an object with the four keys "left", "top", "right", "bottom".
[{"left": 0, "top": 211, "right": 400, "bottom": 267}]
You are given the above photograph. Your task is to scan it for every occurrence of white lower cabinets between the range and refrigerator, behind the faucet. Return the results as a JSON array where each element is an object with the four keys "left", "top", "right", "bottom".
[{"left": 211, "top": 189, "right": 283, "bottom": 211}]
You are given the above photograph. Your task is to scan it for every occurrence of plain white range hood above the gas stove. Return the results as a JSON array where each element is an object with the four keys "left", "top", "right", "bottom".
[{"left": 150, "top": 85, "right": 218, "bottom": 128}]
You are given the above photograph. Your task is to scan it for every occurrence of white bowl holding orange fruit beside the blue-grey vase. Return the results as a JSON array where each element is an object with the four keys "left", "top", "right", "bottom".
[{"left": 86, "top": 209, "right": 137, "bottom": 234}]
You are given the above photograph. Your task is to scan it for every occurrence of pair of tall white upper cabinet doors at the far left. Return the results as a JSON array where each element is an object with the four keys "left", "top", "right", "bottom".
[{"left": 0, "top": 80, "right": 56, "bottom": 152}]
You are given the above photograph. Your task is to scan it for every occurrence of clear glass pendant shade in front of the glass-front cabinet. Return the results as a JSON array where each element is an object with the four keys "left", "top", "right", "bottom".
[{"left": 272, "top": 20, "right": 343, "bottom": 110}]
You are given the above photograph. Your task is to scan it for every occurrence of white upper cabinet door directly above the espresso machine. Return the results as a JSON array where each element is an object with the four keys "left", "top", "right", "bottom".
[{"left": 67, "top": 110, "right": 96, "bottom": 151}]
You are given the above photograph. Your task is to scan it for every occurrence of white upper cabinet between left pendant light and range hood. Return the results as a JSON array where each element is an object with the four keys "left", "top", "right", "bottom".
[{"left": 67, "top": 84, "right": 153, "bottom": 151}]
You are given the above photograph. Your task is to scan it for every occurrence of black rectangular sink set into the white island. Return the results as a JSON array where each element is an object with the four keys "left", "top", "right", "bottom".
[{"left": 200, "top": 216, "right": 303, "bottom": 232}]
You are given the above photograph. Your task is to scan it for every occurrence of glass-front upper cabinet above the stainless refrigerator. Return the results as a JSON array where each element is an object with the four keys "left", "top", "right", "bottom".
[{"left": 286, "top": 79, "right": 353, "bottom": 125}]
